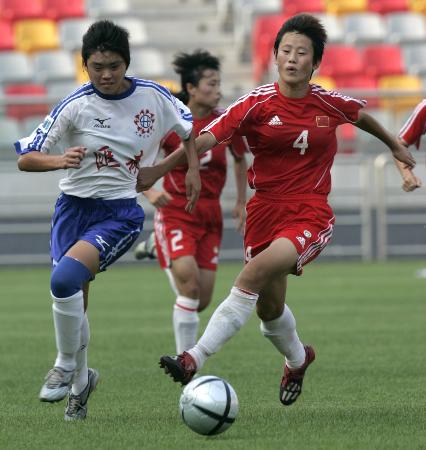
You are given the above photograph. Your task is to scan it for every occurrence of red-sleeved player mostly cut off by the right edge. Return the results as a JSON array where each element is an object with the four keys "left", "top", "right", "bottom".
[{"left": 395, "top": 99, "right": 426, "bottom": 192}]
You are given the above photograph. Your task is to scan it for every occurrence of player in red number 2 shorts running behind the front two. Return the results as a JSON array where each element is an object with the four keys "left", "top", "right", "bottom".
[{"left": 135, "top": 50, "right": 247, "bottom": 353}]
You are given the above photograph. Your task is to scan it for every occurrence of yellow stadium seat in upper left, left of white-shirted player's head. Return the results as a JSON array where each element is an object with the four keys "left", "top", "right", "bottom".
[{"left": 15, "top": 19, "right": 59, "bottom": 53}]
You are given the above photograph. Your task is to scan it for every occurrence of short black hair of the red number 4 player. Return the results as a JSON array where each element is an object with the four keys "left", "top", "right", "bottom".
[{"left": 274, "top": 14, "right": 327, "bottom": 64}]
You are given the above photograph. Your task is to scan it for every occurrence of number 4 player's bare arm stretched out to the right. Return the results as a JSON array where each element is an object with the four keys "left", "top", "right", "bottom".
[{"left": 355, "top": 111, "right": 416, "bottom": 169}]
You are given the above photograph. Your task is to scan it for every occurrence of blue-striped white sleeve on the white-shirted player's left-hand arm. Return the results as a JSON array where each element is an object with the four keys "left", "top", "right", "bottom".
[{"left": 15, "top": 107, "right": 71, "bottom": 155}]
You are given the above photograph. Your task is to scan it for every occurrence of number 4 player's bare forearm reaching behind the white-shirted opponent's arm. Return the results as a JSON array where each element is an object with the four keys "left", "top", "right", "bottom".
[{"left": 137, "top": 133, "right": 217, "bottom": 192}]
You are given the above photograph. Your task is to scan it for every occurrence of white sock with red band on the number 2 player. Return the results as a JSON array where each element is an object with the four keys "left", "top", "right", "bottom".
[{"left": 173, "top": 295, "right": 200, "bottom": 355}]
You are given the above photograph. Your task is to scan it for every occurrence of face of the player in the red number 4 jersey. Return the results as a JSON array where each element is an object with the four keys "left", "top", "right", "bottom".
[{"left": 276, "top": 32, "right": 317, "bottom": 93}]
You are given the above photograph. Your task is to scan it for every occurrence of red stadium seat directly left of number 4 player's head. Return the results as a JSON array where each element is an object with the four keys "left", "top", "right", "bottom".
[{"left": 252, "top": 14, "right": 287, "bottom": 83}]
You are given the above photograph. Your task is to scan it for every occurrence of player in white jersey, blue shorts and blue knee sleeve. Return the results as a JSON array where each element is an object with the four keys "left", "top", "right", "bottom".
[{"left": 15, "top": 20, "right": 200, "bottom": 420}]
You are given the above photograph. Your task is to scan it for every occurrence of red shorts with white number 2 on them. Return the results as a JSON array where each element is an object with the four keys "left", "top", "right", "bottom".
[{"left": 154, "top": 197, "right": 223, "bottom": 270}]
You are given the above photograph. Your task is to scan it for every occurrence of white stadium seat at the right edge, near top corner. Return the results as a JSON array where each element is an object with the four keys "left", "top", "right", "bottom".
[{"left": 386, "top": 12, "right": 426, "bottom": 45}]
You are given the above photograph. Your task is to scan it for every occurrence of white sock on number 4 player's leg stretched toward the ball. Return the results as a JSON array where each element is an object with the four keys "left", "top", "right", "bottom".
[{"left": 189, "top": 286, "right": 259, "bottom": 370}]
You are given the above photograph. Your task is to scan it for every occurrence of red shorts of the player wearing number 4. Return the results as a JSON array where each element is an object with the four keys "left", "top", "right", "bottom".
[{"left": 244, "top": 193, "right": 334, "bottom": 275}]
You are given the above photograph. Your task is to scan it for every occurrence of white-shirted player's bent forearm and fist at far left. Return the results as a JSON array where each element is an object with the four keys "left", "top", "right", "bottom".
[{"left": 18, "top": 147, "right": 86, "bottom": 172}]
